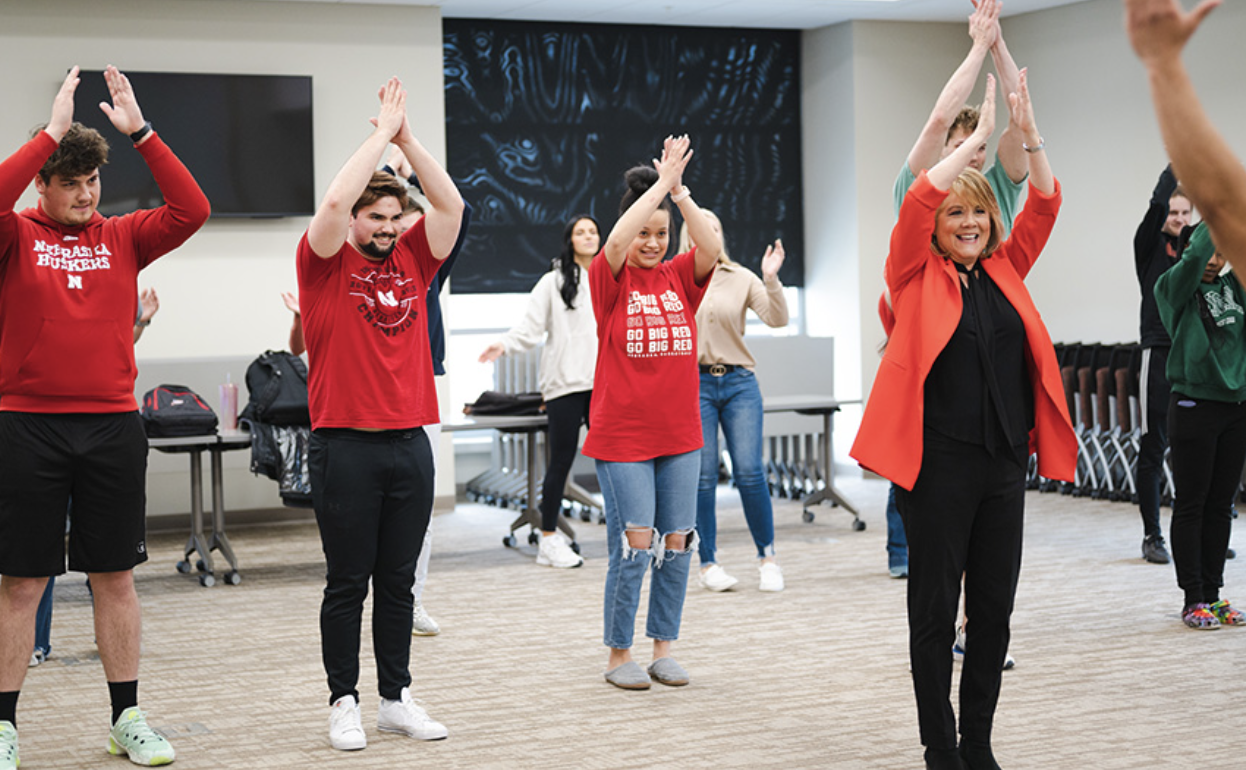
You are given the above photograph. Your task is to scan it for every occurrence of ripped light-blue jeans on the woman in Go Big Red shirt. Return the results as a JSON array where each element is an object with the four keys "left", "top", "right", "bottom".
[{"left": 597, "top": 450, "right": 700, "bottom": 649}]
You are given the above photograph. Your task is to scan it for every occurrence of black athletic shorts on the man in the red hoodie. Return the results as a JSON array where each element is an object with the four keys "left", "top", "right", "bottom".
[{"left": 0, "top": 411, "right": 147, "bottom": 577}]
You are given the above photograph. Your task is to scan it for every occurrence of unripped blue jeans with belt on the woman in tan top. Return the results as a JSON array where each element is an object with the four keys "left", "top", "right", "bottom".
[{"left": 697, "top": 369, "right": 775, "bottom": 564}]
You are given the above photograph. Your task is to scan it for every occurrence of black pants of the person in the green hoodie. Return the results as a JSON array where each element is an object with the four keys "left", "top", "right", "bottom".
[{"left": 1169, "top": 391, "right": 1246, "bottom": 606}]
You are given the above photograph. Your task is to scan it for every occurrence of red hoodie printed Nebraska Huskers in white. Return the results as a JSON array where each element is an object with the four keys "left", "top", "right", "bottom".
[{"left": 0, "top": 131, "right": 209, "bottom": 414}]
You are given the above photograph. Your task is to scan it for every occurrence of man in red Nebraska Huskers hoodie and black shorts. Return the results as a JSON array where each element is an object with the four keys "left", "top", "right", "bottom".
[{"left": 0, "top": 66, "right": 209, "bottom": 770}]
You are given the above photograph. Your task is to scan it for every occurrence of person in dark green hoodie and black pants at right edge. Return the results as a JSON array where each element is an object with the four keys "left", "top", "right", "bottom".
[{"left": 1155, "top": 222, "right": 1246, "bottom": 629}]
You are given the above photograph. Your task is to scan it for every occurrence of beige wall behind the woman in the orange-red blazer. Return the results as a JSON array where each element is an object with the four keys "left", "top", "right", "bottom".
[{"left": 802, "top": 0, "right": 1246, "bottom": 443}]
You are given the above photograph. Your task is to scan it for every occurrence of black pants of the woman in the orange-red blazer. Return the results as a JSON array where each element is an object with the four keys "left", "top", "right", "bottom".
[{"left": 896, "top": 431, "right": 1025, "bottom": 749}]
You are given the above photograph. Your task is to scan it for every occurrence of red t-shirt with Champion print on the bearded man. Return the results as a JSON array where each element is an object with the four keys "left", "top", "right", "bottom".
[{"left": 298, "top": 218, "right": 441, "bottom": 430}]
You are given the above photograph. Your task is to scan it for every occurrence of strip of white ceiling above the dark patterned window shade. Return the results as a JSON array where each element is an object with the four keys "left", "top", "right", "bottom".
[{"left": 260, "top": 0, "right": 1083, "bottom": 30}]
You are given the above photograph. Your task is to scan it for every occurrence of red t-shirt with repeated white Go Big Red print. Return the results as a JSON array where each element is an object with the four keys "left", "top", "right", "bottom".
[{"left": 583, "top": 248, "right": 709, "bottom": 462}]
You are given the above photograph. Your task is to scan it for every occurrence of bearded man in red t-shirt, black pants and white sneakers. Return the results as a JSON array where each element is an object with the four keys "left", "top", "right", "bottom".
[{"left": 298, "top": 78, "right": 468, "bottom": 751}]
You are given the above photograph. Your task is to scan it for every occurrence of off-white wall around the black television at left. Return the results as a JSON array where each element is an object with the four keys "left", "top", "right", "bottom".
[{"left": 0, "top": 0, "right": 454, "bottom": 513}]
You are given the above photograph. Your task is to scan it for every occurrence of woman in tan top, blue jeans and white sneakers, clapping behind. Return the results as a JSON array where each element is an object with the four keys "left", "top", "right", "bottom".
[{"left": 679, "top": 209, "right": 787, "bottom": 591}]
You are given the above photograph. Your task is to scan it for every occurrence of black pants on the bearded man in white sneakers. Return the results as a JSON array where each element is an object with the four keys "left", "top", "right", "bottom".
[{"left": 308, "top": 427, "right": 434, "bottom": 703}]
